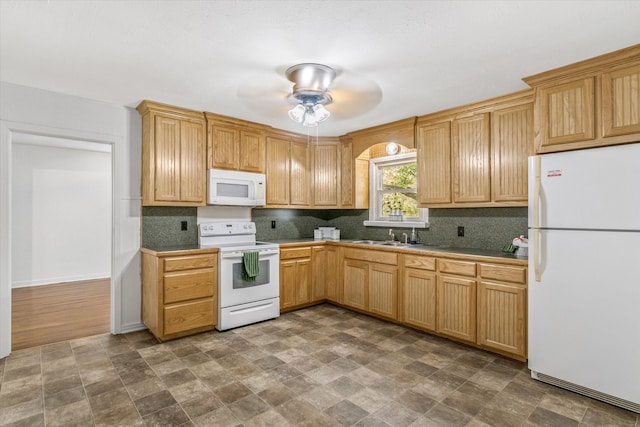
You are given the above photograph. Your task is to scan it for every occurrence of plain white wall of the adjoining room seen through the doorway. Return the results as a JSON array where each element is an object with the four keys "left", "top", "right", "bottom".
[{"left": 11, "top": 143, "right": 112, "bottom": 288}]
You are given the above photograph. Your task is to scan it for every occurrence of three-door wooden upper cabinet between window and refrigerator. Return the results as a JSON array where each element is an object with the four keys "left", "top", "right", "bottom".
[{"left": 416, "top": 90, "right": 534, "bottom": 208}]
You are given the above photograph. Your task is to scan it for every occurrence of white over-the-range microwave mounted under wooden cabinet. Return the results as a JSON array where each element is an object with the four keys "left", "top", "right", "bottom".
[{"left": 207, "top": 169, "right": 266, "bottom": 206}]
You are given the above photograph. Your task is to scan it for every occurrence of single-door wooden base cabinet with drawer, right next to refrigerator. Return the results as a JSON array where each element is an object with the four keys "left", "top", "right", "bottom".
[{"left": 478, "top": 264, "right": 527, "bottom": 360}]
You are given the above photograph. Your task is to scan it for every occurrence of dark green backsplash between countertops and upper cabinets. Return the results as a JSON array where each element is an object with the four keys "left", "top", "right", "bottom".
[{"left": 142, "top": 207, "right": 527, "bottom": 250}]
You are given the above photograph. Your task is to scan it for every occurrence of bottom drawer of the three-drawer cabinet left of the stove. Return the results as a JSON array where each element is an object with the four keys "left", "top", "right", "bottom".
[{"left": 164, "top": 298, "right": 214, "bottom": 335}]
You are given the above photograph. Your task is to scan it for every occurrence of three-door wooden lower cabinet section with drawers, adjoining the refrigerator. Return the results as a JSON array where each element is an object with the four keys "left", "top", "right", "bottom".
[{"left": 399, "top": 254, "right": 527, "bottom": 361}]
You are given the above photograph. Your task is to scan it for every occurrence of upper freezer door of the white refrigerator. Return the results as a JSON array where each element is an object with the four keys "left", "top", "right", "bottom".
[{"left": 529, "top": 143, "right": 640, "bottom": 230}]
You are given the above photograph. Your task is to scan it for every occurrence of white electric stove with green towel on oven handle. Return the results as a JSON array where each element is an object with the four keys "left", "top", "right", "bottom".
[{"left": 198, "top": 221, "right": 280, "bottom": 331}]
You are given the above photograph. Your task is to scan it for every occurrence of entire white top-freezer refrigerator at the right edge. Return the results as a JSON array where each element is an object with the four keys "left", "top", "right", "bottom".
[{"left": 529, "top": 143, "right": 640, "bottom": 413}]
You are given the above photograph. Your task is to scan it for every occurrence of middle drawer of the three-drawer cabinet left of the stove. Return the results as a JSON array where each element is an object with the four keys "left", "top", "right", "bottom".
[{"left": 164, "top": 268, "right": 215, "bottom": 304}]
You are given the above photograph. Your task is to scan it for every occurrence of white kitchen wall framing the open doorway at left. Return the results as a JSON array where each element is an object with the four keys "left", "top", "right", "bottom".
[{"left": 0, "top": 82, "right": 144, "bottom": 357}]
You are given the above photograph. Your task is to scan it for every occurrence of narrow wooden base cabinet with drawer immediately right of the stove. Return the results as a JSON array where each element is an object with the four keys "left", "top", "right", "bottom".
[{"left": 280, "top": 246, "right": 311, "bottom": 310}]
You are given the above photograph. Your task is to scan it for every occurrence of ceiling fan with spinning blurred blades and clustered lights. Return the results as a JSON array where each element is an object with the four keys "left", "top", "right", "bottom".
[{"left": 238, "top": 62, "right": 382, "bottom": 127}]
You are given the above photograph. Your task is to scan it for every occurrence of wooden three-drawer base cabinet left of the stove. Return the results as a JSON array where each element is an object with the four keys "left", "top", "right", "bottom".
[{"left": 142, "top": 249, "right": 218, "bottom": 341}]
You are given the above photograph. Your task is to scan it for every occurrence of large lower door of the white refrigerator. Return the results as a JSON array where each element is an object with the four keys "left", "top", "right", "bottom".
[{"left": 528, "top": 230, "right": 640, "bottom": 405}]
